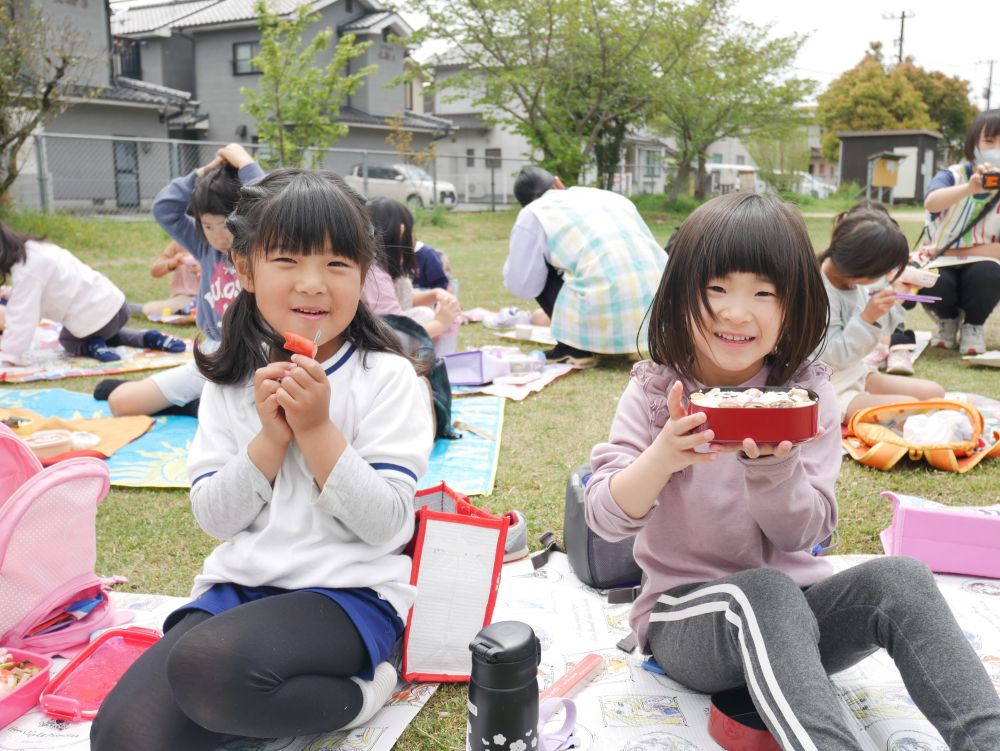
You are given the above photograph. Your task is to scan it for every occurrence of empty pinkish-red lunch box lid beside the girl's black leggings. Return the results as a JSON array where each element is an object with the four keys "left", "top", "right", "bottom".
[{"left": 39, "top": 628, "right": 160, "bottom": 722}]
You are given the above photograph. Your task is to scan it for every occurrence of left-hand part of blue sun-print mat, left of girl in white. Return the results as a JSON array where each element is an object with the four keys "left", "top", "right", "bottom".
[{"left": 0, "top": 389, "right": 198, "bottom": 488}]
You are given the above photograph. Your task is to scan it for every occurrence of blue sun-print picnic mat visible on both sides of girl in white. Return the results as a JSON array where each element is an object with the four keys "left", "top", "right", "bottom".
[{"left": 0, "top": 389, "right": 504, "bottom": 495}]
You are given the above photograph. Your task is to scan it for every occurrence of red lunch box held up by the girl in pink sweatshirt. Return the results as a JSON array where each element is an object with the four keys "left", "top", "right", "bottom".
[{"left": 688, "top": 386, "right": 819, "bottom": 444}]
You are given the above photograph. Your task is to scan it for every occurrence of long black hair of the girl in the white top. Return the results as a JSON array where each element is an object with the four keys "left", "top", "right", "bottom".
[{"left": 194, "top": 169, "right": 405, "bottom": 384}]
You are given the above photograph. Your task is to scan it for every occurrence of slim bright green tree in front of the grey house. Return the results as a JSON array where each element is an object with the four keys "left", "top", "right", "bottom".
[{"left": 240, "top": 0, "right": 376, "bottom": 167}]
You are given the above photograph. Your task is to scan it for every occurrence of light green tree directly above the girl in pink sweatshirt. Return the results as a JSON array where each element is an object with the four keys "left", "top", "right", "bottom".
[{"left": 654, "top": 0, "right": 815, "bottom": 199}]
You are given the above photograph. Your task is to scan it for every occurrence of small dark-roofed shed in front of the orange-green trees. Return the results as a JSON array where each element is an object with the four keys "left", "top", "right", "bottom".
[{"left": 837, "top": 130, "right": 941, "bottom": 203}]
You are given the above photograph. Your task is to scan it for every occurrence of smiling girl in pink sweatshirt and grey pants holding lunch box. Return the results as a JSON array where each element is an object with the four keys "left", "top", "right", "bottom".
[{"left": 587, "top": 193, "right": 1000, "bottom": 751}]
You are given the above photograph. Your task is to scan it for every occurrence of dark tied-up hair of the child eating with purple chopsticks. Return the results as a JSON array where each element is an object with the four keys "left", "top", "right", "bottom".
[{"left": 819, "top": 201, "right": 910, "bottom": 279}]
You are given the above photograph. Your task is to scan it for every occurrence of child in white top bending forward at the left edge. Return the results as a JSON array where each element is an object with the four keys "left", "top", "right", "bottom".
[{"left": 0, "top": 222, "right": 186, "bottom": 365}]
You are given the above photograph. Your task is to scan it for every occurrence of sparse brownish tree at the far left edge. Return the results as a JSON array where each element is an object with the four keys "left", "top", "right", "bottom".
[{"left": 0, "top": 0, "right": 92, "bottom": 206}]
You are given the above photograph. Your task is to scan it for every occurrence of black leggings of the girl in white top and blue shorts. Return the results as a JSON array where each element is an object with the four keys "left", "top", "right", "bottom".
[{"left": 90, "top": 592, "right": 369, "bottom": 751}]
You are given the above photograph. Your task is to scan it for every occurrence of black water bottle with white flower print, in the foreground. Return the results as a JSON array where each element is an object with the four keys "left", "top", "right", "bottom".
[{"left": 465, "top": 621, "right": 542, "bottom": 751}]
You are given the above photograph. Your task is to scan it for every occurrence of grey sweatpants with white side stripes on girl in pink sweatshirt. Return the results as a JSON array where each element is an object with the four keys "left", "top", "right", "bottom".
[{"left": 648, "top": 557, "right": 1000, "bottom": 751}]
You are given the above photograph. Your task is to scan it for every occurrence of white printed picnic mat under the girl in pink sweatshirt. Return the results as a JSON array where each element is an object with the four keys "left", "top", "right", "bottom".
[{"left": 493, "top": 554, "right": 1000, "bottom": 751}]
